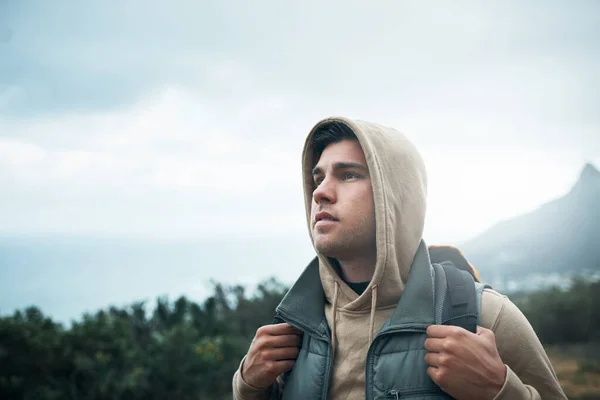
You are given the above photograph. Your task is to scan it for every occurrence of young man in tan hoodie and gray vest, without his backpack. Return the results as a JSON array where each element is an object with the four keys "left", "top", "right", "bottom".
[{"left": 233, "top": 118, "right": 566, "bottom": 400}]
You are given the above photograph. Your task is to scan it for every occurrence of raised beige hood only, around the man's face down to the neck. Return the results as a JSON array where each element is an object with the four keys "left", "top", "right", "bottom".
[{"left": 302, "top": 117, "right": 427, "bottom": 311}]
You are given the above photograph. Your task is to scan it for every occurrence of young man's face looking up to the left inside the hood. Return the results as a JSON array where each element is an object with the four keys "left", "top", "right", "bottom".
[{"left": 311, "top": 140, "right": 376, "bottom": 260}]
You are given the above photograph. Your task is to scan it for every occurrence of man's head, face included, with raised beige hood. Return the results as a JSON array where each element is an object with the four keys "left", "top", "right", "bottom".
[{"left": 302, "top": 118, "right": 427, "bottom": 311}]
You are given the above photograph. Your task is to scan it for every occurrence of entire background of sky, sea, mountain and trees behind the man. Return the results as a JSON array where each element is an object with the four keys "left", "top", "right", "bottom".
[{"left": 0, "top": 0, "right": 600, "bottom": 399}]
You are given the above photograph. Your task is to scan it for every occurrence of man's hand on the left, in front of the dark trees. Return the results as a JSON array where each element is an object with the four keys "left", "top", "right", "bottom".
[{"left": 242, "top": 323, "right": 302, "bottom": 389}]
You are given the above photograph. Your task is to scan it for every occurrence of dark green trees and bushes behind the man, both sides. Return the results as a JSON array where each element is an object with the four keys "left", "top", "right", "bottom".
[{"left": 0, "top": 279, "right": 600, "bottom": 400}]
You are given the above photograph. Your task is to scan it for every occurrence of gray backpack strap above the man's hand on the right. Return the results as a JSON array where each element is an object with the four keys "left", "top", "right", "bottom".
[{"left": 433, "top": 262, "right": 483, "bottom": 333}]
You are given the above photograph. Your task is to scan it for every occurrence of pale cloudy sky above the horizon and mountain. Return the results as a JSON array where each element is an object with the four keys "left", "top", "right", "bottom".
[{"left": 0, "top": 0, "right": 600, "bottom": 244}]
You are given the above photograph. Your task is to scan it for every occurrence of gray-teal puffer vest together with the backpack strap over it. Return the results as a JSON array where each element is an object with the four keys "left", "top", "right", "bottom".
[{"left": 275, "top": 243, "right": 487, "bottom": 400}]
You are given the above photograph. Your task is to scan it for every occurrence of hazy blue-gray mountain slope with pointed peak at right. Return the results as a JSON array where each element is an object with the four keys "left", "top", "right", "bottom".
[{"left": 460, "top": 164, "right": 600, "bottom": 290}]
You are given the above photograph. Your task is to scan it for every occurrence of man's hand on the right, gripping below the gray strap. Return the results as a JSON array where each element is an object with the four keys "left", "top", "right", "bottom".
[{"left": 425, "top": 325, "right": 506, "bottom": 400}]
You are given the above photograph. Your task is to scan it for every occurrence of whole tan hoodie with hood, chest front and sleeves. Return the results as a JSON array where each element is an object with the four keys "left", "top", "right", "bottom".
[{"left": 233, "top": 117, "right": 566, "bottom": 400}]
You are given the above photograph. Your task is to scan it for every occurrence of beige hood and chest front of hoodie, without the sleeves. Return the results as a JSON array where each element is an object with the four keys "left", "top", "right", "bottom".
[{"left": 302, "top": 117, "right": 427, "bottom": 400}]
